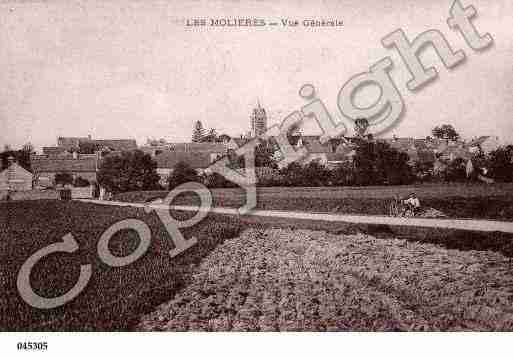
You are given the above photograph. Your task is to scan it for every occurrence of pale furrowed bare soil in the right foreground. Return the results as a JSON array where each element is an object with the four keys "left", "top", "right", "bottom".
[{"left": 137, "top": 228, "right": 513, "bottom": 331}]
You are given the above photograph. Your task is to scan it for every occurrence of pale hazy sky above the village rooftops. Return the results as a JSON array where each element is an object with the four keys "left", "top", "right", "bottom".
[{"left": 0, "top": 0, "right": 513, "bottom": 148}]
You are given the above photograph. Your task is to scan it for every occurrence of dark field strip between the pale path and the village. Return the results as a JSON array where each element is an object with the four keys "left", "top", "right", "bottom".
[{"left": 115, "top": 183, "right": 513, "bottom": 221}]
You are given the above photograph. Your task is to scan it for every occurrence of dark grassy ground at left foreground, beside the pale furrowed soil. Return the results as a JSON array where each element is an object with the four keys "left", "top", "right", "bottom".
[{"left": 0, "top": 200, "right": 240, "bottom": 331}]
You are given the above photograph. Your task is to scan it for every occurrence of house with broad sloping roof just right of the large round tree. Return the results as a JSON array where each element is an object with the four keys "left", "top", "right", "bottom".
[{"left": 153, "top": 150, "right": 212, "bottom": 186}]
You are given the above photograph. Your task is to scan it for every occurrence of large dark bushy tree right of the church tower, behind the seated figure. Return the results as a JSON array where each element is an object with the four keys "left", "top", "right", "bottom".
[{"left": 353, "top": 139, "right": 414, "bottom": 186}]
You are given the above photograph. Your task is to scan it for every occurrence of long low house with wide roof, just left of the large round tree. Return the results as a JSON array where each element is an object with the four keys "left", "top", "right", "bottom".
[{"left": 31, "top": 152, "right": 99, "bottom": 187}]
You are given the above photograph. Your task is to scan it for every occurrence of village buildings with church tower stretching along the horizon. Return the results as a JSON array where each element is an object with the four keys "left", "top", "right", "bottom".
[{"left": 0, "top": 103, "right": 501, "bottom": 199}]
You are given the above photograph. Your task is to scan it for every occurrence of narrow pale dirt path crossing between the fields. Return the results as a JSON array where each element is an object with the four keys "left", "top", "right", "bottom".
[{"left": 81, "top": 200, "right": 513, "bottom": 233}]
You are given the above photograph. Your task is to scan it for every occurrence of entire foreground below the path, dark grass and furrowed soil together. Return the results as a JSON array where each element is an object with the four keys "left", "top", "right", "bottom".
[{"left": 0, "top": 194, "right": 513, "bottom": 331}]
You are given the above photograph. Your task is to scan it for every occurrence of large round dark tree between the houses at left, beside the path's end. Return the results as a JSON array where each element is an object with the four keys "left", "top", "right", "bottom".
[{"left": 97, "top": 150, "right": 160, "bottom": 193}]
